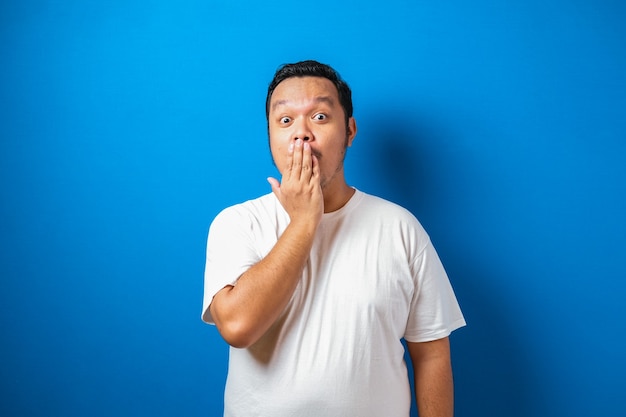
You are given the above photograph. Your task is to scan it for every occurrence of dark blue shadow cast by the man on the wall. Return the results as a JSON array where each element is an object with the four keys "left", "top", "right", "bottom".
[{"left": 363, "top": 112, "right": 538, "bottom": 417}]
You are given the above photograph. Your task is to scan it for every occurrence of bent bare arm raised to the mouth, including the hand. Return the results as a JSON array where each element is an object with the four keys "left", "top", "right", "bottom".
[{"left": 209, "top": 140, "right": 324, "bottom": 347}]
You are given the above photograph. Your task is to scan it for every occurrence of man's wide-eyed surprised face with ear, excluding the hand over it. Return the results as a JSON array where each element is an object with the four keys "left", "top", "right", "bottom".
[{"left": 268, "top": 77, "right": 356, "bottom": 188}]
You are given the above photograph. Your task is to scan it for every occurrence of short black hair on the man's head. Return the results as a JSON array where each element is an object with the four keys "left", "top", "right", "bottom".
[{"left": 265, "top": 60, "right": 352, "bottom": 125}]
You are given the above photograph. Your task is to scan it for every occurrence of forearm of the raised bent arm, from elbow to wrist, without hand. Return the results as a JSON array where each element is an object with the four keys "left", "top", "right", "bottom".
[{"left": 210, "top": 218, "right": 316, "bottom": 347}]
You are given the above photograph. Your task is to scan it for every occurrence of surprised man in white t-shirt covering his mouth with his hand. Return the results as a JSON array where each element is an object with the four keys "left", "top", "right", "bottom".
[{"left": 202, "top": 61, "right": 465, "bottom": 417}]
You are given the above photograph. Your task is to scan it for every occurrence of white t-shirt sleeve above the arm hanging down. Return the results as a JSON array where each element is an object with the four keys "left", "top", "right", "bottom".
[{"left": 404, "top": 240, "right": 465, "bottom": 342}]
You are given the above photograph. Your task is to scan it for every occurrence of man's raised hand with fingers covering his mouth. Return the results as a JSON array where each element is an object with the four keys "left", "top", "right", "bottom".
[{"left": 267, "top": 139, "right": 324, "bottom": 226}]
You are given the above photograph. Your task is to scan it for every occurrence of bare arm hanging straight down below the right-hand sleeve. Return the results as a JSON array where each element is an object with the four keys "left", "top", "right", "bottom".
[{"left": 407, "top": 337, "right": 454, "bottom": 417}]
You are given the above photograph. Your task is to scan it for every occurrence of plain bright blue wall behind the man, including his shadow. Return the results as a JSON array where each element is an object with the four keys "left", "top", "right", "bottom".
[{"left": 0, "top": 0, "right": 626, "bottom": 417}]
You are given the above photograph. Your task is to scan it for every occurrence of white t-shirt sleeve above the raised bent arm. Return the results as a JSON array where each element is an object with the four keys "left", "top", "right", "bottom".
[{"left": 202, "top": 206, "right": 260, "bottom": 324}]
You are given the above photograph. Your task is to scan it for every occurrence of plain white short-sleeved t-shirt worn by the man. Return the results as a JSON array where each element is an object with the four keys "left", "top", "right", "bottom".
[{"left": 202, "top": 190, "right": 465, "bottom": 417}]
